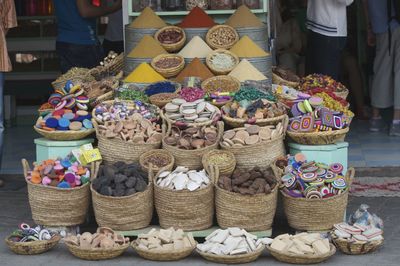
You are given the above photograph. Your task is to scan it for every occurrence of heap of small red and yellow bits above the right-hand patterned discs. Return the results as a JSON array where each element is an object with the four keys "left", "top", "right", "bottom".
[{"left": 299, "top": 74, "right": 349, "bottom": 100}]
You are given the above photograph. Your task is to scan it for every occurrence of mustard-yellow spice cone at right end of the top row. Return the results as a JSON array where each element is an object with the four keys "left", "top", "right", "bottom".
[{"left": 225, "top": 5, "right": 264, "bottom": 28}]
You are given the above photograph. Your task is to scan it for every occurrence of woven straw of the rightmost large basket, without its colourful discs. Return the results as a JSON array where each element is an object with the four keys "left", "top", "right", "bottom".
[{"left": 281, "top": 168, "right": 355, "bottom": 231}]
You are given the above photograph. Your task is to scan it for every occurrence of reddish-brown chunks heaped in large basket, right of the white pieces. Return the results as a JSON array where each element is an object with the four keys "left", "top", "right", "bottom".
[{"left": 218, "top": 167, "right": 278, "bottom": 195}]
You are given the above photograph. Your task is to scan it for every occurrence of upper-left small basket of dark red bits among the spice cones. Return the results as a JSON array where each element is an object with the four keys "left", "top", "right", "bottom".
[{"left": 154, "top": 26, "right": 186, "bottom": 52}]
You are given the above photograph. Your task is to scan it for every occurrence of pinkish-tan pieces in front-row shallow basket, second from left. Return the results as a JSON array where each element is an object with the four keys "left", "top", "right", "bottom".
[{"left": 64, "top": 227, "right": 129, "bottom": 250}]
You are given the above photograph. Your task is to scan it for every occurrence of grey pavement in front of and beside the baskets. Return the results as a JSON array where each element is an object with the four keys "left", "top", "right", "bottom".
[{"left": 0, "top": 176, "right": 400, "bottom": 266}]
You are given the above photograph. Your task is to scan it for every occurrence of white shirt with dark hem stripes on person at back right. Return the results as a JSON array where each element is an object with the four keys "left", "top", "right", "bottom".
[{"left": 307, "top": 0, "right": 353, "bottom": 37}]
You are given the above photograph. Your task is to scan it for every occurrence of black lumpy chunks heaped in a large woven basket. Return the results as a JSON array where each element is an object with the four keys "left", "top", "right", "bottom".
[{"left": 92, "top": 162, "right": 148, "bottom": 197}]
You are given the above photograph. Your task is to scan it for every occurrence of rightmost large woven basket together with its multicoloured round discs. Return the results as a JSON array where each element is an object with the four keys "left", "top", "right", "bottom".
[{"left": 272, "top": 153, "right": 355, "bottom": 231}]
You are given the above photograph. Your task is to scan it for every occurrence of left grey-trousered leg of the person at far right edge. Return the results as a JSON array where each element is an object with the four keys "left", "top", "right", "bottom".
[{"left": 370, "top": 30, "right": 393, "bottom": 132}]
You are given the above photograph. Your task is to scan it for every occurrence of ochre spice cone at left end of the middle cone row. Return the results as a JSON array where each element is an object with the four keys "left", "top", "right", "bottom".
[{"left": 128, "top": 35, "right": 168, "bottom": 58}]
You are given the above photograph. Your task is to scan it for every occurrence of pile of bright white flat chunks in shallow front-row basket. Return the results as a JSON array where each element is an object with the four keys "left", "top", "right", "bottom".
[{"left": 197, "top": 227, "right": 272, "bottom": 255}]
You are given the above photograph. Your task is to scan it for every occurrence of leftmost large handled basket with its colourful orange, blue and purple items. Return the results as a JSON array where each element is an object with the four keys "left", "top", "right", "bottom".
[{"left": 22, "top": 158, "right": 96, "bottom": 226}]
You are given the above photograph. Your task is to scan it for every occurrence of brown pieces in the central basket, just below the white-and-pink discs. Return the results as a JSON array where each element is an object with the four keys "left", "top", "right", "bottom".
[{"left": 164, "top": 126, "right": 218, "bottom": 150}]
